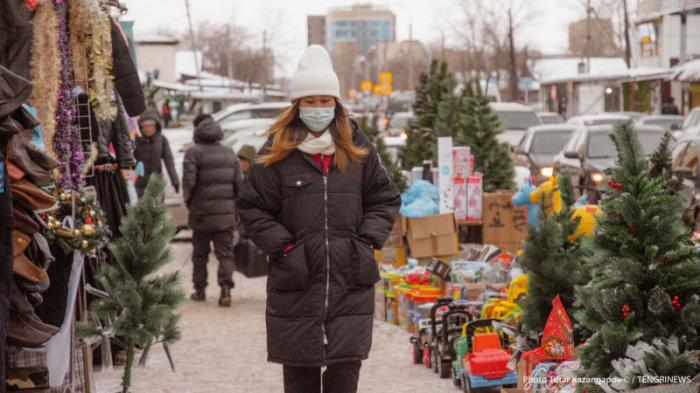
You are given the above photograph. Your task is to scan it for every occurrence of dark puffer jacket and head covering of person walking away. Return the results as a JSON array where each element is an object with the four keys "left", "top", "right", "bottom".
[{"left": 182, "top": 119, "right": 242, "bottom": 232}]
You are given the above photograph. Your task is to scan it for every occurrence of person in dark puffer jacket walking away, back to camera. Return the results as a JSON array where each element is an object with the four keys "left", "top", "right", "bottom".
[{"left": 182, "top": 117, "right": 242, "bottom": 307}]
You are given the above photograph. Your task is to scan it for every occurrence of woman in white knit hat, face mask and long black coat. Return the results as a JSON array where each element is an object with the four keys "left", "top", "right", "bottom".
[{"left": 238, "top": 45, "right": 401, "bottom": 393}]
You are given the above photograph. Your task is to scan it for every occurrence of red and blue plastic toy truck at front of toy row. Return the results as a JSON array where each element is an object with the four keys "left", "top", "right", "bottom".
[{"left": 455, "top": 319, "right": 518, "bottom": 393}]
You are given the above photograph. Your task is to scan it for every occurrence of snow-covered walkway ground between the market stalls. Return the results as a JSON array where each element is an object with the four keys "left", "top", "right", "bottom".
[{"left": 95, "top": 243, "right": 460, "bottom": 393}]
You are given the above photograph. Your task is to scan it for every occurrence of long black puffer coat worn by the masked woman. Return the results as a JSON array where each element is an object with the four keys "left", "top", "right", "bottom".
[{"left": 238, "top": 123, "right": 400, "bottom": 367}]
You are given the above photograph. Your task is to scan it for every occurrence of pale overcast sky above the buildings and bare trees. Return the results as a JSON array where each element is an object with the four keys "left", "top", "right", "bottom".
[{"left": 122, "top": 0, "right": 596, "bottom": 75}]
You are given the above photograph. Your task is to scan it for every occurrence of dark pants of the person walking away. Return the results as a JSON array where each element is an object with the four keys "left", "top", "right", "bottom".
[{"left": 192, "top": 231, "right": 235, "bottom": 289}]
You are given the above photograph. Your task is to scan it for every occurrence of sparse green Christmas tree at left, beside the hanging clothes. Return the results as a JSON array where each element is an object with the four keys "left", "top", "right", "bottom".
[{"left": 79, "top": 175, "right": 185, "bottom": 393}]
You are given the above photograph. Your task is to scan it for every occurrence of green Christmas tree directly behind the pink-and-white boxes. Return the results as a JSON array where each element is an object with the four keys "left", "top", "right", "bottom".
[{"left": 455, "top": 81, "right": 515, "bottom": 192}]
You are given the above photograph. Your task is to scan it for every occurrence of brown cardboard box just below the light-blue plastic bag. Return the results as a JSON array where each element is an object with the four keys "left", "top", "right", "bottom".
[{"left": 406, "top": 213, "right": 459, "bottom": 258}]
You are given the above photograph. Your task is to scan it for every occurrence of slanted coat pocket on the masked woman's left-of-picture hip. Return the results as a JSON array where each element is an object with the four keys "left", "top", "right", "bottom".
[{"left": 268, "top": 243, "right": 309, "bottom": 291}]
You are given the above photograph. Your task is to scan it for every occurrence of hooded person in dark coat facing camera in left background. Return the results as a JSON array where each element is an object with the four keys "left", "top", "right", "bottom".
[{"left": 134, "top": 110, "right": 180, "bottom": 198}]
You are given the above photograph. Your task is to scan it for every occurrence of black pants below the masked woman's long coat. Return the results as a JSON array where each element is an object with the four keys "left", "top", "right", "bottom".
[{"left": 284, "top": 360, "right": 362, "bottom": 393}]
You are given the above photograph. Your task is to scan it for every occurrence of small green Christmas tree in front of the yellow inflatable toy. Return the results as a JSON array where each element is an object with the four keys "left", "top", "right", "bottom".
[{"left": 519, "top": 175, "right": 589, "bottom": 344}]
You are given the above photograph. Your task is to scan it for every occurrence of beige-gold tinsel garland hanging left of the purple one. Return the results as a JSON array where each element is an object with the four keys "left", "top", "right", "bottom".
[{"left": 31, "top": 1, "right": 61, "bottom": 158}]
